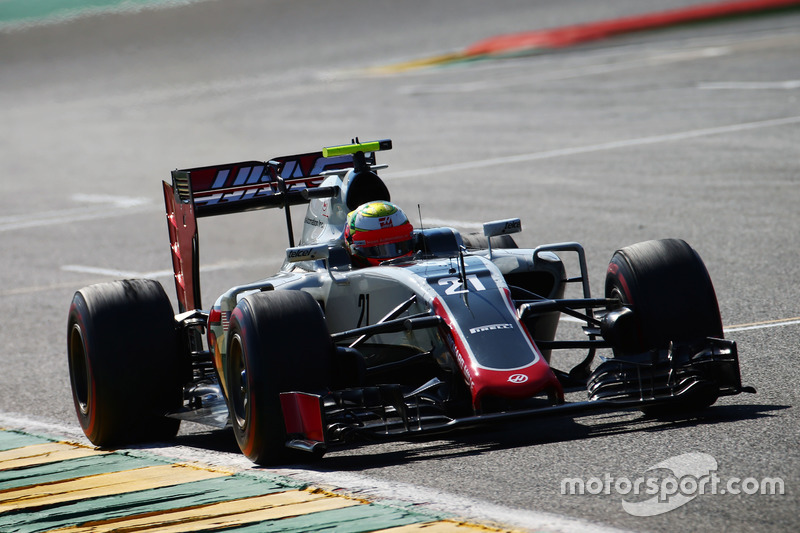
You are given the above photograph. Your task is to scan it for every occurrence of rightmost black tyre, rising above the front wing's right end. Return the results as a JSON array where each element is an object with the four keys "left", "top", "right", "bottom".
[{"left": 605, "top": 239, "right": 722, "bottom": 351}]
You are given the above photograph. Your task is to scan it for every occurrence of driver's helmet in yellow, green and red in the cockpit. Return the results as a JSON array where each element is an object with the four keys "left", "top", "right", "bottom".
[{"left": 344, "top": 201, "right": 414, "bottom": 266}]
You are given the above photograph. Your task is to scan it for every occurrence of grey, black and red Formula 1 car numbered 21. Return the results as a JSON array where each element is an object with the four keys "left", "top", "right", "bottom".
[{"left": 68, "top": 139, "right": 755, "bottom": 464}]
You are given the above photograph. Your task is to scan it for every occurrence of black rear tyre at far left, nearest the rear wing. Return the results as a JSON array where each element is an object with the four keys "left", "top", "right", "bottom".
[{"left": 67, "top": 280, "right": 183, "bottom": 447}]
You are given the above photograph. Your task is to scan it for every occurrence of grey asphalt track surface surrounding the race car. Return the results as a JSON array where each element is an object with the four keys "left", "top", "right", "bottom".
[{"left": 0, "top": 0, "right": 800, "bottom": 531}]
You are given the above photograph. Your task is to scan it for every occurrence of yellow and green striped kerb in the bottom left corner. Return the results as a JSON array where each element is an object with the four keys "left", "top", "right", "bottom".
[{"left": 0, "top": 428, "right": 508, "bottom": 533}]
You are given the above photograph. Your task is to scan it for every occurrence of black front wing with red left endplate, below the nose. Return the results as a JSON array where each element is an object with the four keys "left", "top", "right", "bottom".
[{"left": 281, "top": 339, "right": 755, "bottom": 454}]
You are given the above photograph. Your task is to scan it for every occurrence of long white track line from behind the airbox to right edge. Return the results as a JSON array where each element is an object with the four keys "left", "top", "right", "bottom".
[{"left": 384, "top": 116, "right": 800, "bottom": 180}]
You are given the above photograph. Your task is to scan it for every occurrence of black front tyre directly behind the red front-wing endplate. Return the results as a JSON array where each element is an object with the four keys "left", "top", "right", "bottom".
[{"left": 225, "top": 291, "right": 334, "bottom": 465}]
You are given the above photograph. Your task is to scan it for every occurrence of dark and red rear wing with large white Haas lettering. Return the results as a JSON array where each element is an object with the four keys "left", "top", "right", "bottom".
[{"left": 163, "top": 139, "right": 392, "bottom": 312}]
